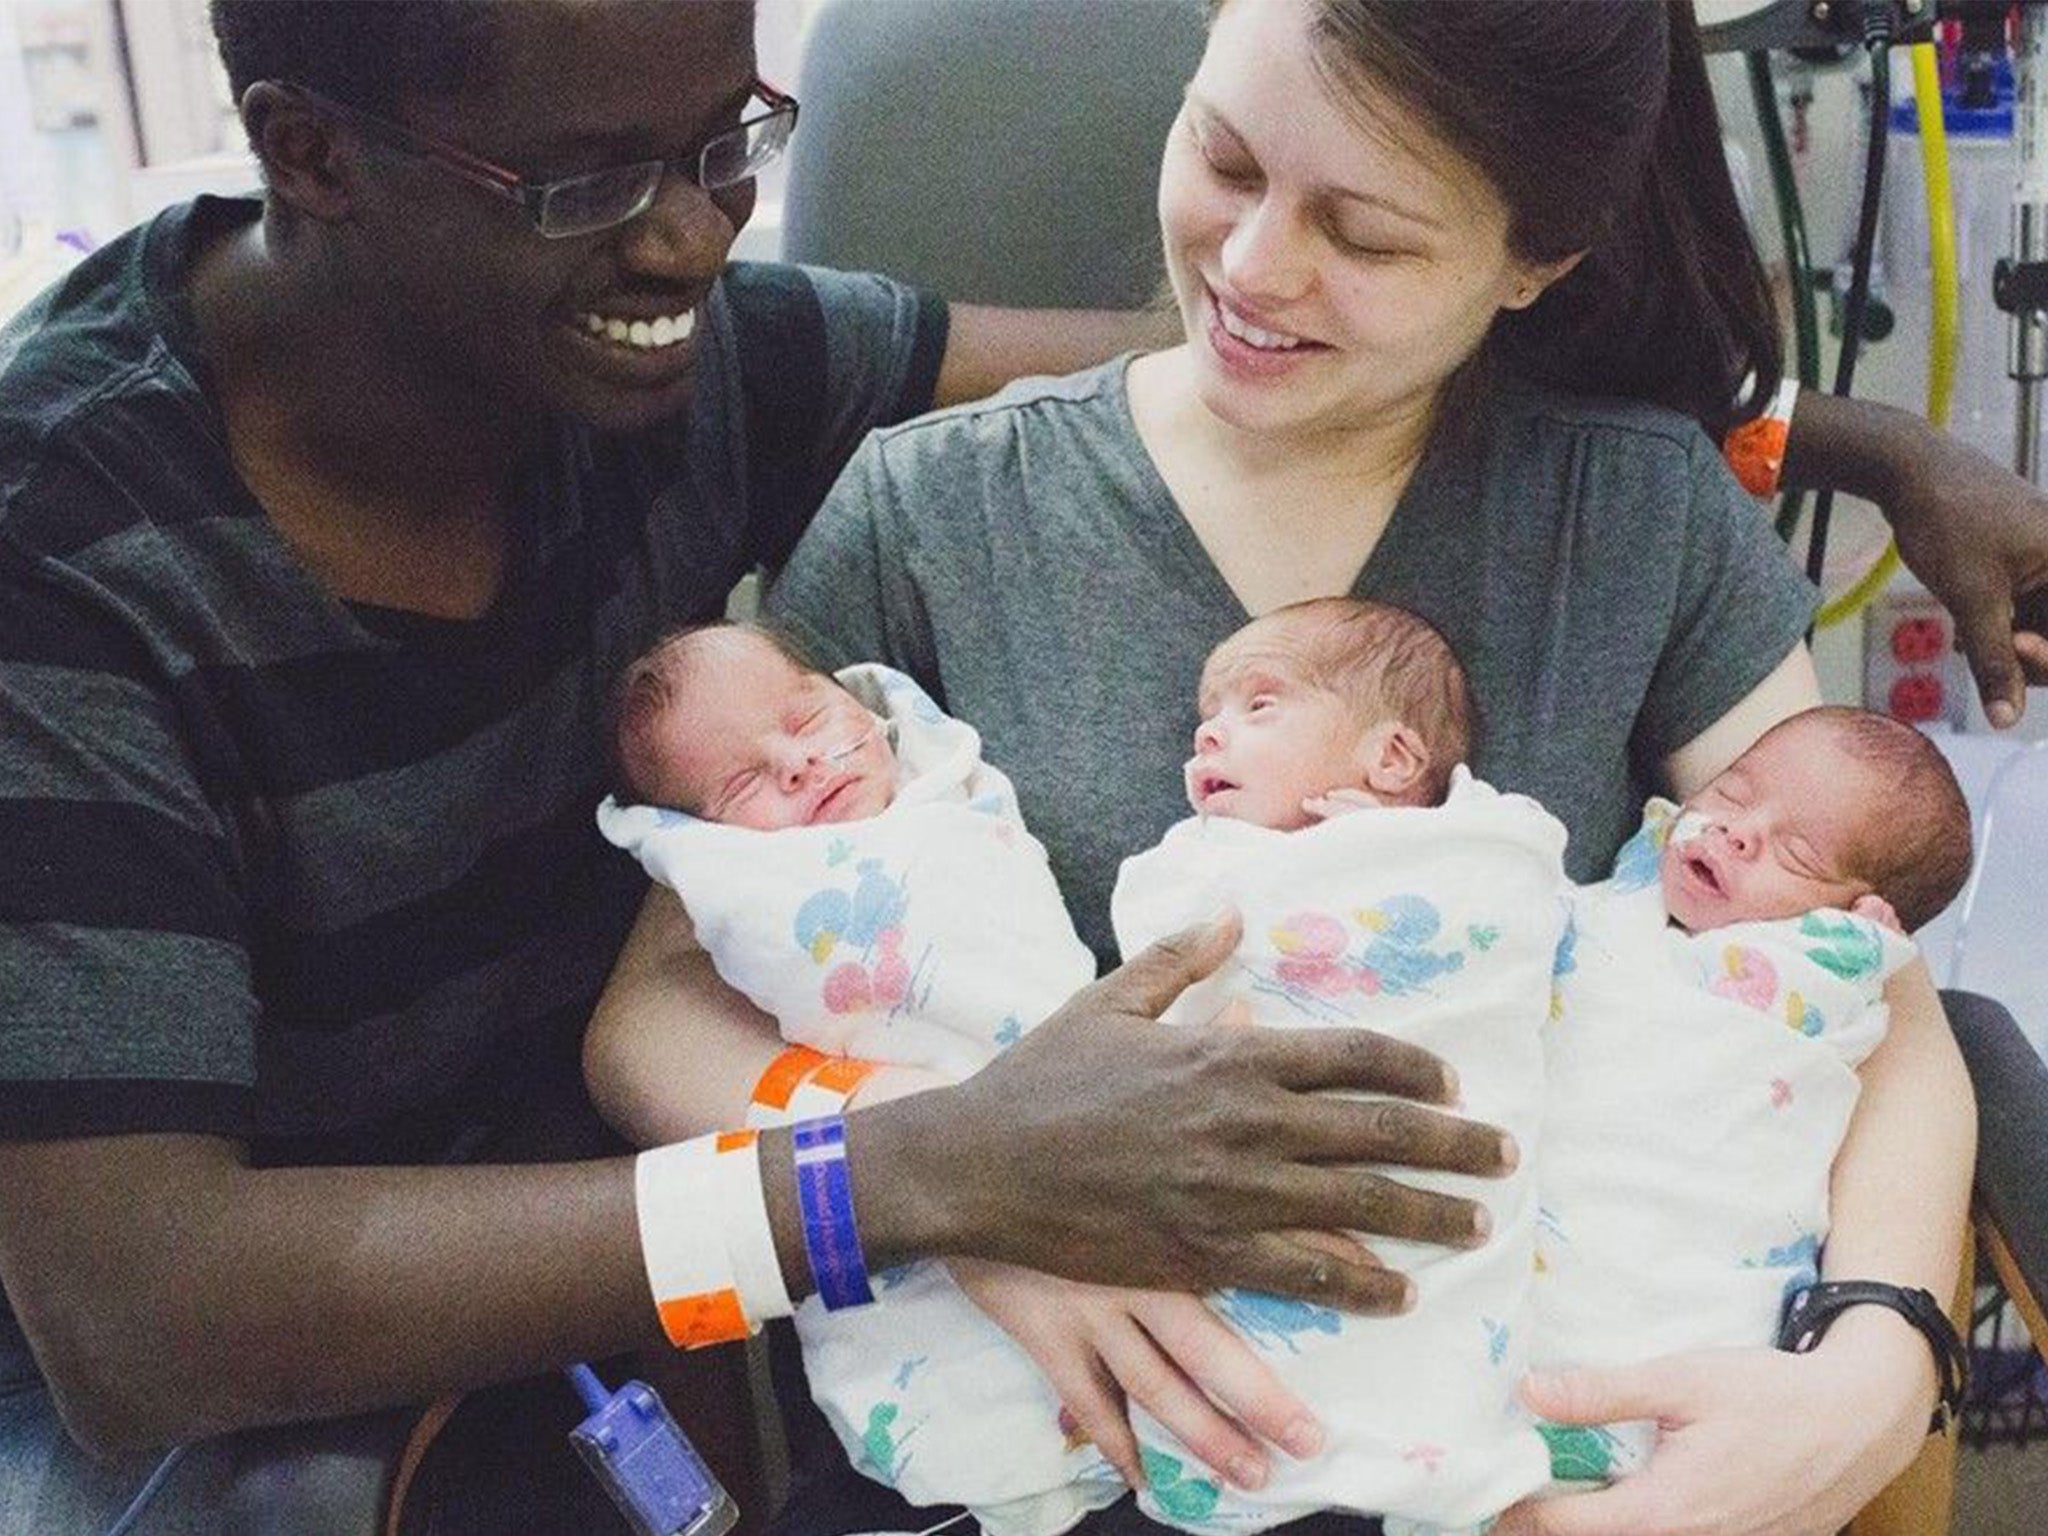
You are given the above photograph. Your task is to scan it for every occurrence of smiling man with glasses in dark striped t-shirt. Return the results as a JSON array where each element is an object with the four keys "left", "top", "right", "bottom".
[{"left": 0, "top": 0, "right": 1501, "bottom": 1536}]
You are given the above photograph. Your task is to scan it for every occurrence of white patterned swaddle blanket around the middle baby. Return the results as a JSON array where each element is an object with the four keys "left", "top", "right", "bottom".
[{"left": 1110, "top": 768, "right": 1567, "bottom": 1532}]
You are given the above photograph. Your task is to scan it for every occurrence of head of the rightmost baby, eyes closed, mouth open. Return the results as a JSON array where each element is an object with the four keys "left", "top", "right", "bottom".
[{"left": 1659, "top": 705, "right": 1970, "bottom": 932}]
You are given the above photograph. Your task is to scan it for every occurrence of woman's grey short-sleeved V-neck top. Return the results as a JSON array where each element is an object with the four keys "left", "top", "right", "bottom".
[{"left": 770, "top": 360, "right": 1812, "bottom": 965}]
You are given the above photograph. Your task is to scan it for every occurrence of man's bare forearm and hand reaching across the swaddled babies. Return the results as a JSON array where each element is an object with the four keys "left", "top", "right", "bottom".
[{"left": 0, "top": 909, "right": 1507, "bottom": 1450}]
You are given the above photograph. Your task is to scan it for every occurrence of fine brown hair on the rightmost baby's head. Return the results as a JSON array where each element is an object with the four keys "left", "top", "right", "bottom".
[{"left": 1759, "top": 705, "right": 1970, "bottom": 932}]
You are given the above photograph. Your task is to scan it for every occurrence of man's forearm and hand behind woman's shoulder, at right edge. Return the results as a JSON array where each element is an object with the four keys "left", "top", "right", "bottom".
[{"left": 1784, "top": 389, "right": 2048, "bottom": 725}]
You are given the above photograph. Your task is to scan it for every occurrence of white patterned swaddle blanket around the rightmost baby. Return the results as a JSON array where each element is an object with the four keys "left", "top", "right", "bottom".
[{"left": 1530, "top": 801, "right": 1915, "bottom": 1479}]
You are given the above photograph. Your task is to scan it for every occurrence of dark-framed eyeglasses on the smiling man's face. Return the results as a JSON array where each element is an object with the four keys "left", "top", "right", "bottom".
[{"left": 289, "top": 80, "right": 797, "bottom": 240}]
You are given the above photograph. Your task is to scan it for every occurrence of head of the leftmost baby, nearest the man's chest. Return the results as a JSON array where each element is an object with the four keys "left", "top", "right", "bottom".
[{"left": 612, "top": 625, "right": 895, "bottom": 831}]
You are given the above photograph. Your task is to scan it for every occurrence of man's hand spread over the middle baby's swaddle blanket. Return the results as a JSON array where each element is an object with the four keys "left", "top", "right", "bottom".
[{"left": 848, "top": 918, "right": 1516, "bottom": 1313}]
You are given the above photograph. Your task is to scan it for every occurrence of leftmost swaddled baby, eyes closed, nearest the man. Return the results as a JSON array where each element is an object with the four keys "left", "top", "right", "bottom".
[{"left": 598, "top": 625, "right": 1124, "bottom": 1536}]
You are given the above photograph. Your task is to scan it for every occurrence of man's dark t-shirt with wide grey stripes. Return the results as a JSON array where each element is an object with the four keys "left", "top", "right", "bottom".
[{"left": 0, "top": 199, "right": 946, "bottom": 1163}]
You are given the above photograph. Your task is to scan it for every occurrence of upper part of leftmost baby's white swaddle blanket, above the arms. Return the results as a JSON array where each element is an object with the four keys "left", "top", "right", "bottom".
[{"left": 598, "top": 666, "right": 1096, "bottom": 1079}]
